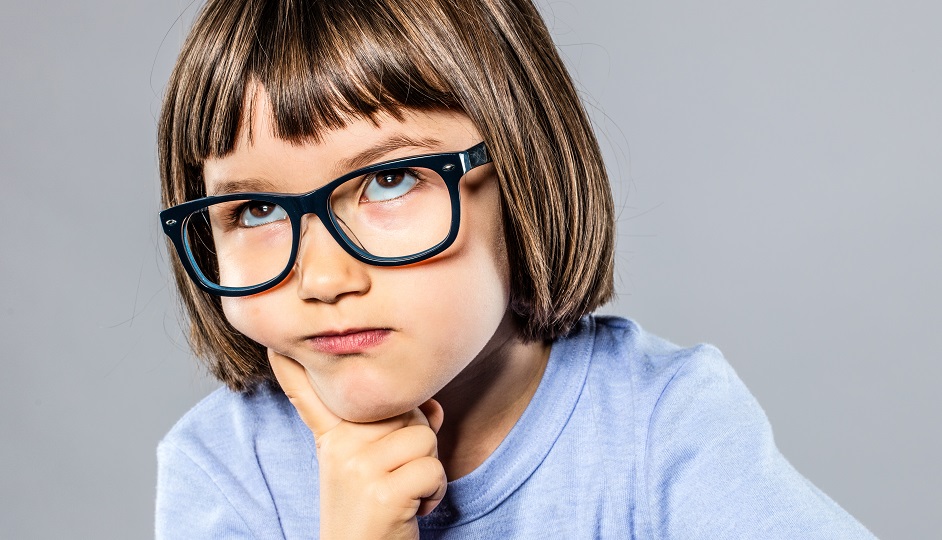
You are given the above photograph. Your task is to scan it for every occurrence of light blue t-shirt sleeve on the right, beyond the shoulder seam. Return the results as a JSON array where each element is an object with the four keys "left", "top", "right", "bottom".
[{"left": 643, "top": 346, "right": 874, "bottom": 540}]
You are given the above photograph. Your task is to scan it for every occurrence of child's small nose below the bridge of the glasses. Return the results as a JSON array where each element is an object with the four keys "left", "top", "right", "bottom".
[{"left": 294, "top": 214, "right": 370, "bottom": 304}]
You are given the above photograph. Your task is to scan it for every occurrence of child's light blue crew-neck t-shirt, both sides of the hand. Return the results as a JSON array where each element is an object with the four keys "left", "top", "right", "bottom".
[{"left": 156, "top": 317, "right": 873, "bottom": 540}]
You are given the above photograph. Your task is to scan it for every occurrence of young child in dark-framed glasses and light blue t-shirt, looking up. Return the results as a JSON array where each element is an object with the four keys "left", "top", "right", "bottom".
[{"left": 156, "top": 0, "right": 872, "bottom": 539}]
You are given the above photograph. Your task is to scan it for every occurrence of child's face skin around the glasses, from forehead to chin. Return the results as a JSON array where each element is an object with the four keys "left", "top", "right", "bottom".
[{"left": 203, "top": 92, "right": 513, "bottom": 422}]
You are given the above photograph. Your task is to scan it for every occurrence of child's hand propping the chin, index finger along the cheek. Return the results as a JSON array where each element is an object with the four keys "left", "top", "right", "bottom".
[{"left": 268, "top": 349, "right": 448, "bottom": 540}]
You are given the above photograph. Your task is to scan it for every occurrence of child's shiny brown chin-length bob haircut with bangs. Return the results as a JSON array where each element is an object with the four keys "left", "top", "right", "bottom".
[{"left": 158, "top": 0, "right": 614, "bottom": 392}]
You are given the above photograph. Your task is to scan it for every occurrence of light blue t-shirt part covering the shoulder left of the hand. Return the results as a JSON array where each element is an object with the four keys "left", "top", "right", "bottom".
[{"left": 155, "top": 388, "right": 314, "bottom": 538}]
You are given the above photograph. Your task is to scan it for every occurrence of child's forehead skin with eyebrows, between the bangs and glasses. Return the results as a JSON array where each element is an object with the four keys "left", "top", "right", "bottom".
[{"left": 203, "top": 87, "right": 481, "bottom": 195}]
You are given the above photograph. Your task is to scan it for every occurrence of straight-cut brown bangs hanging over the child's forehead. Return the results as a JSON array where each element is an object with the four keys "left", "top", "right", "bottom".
[{"left": 169, "top": 0, "right": 465, "bottom": 175}]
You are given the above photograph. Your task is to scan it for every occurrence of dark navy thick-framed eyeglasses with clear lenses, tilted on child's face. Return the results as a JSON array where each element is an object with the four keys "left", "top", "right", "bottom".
[{"left": 160, "top": 142, "right": 491, "bottom": 296}]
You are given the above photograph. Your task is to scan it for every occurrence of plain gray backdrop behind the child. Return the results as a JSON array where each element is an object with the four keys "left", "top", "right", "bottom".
[{"left": 0, "top": 0, "right": 942, "bottom": 538}]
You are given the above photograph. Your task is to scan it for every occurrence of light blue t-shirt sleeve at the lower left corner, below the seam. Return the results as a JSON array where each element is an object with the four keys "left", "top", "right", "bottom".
[{"left": 155, "top": 442, "right": 257, "bottom": 540}]
